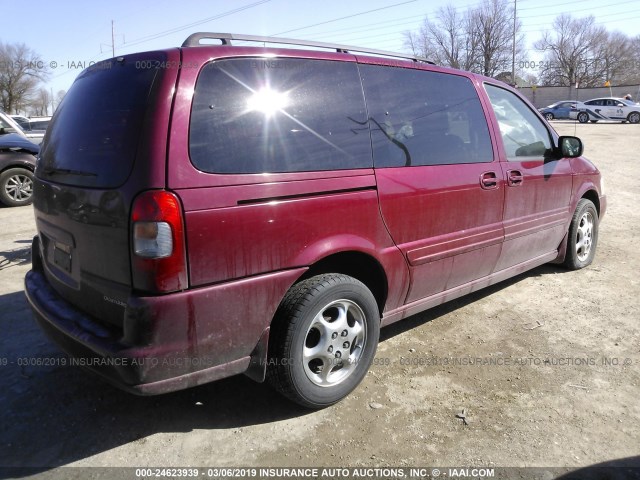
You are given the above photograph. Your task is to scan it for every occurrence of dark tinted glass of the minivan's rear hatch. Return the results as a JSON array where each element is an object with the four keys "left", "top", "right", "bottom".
[{"left": 36, "top": 53, "right": 164, "bottom": 188}]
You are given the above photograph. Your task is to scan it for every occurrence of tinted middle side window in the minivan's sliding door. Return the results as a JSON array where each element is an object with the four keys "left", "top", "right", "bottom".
[{"left": 360, "top": 65, "right": 493, "bottom": 168}]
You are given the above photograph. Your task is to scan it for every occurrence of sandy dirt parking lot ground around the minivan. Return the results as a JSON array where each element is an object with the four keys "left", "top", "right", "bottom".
[{"left": 0, "top": 122, "right": 640, "bottom": 478}]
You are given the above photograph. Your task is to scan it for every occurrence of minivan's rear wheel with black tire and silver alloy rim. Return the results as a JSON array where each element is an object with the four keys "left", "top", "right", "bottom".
[{"left": 267, "top": 273, "right": 380, "bottom": 408}]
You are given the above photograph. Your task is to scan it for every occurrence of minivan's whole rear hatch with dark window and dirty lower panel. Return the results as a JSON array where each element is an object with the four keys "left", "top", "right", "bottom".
[{"left": 34, "top": 49, "right": 179, "bottom": 326}]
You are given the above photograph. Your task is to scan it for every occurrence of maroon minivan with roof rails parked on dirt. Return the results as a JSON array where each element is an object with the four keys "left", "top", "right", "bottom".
[{"left": 26, "top": 33, "right": 606, "bottom": 408}]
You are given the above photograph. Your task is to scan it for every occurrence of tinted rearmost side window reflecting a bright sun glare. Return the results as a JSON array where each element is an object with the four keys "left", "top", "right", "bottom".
[{"left": 189, "top": 58, "right": 373, "bottom": 173}]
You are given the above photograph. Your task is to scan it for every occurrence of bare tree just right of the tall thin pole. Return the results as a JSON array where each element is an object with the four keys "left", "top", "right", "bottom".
[{"left": 534, "top": 14, "right": 608, "bottom": 87}]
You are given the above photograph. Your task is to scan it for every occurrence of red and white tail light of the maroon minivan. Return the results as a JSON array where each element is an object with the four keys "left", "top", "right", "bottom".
[{"left": 131, "top": 190, "right": 187, "bottom": 293}]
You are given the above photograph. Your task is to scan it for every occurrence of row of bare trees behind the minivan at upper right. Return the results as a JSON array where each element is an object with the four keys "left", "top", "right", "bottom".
[{"left": 404, "top": 0, "right": 640, "bottom": 87}]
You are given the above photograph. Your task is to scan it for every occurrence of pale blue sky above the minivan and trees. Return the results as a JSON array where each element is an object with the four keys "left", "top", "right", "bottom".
[{"left": 0, "top": 0, "right": 640, "bottom": 92}]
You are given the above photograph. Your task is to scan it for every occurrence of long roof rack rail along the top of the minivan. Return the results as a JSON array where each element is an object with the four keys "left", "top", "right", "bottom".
[{"left": 182, "top": 32, "right": 435, "bottom": 65}]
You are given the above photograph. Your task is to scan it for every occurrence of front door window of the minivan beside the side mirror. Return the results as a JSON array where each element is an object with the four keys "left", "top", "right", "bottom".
[{"left": 485, "top": 84, "right": 551, "bottom": 161}]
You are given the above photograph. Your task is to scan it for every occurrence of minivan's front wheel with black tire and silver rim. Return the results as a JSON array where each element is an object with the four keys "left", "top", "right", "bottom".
[{"left": 564, "top": 198, "right": 599, "bottom": 270}]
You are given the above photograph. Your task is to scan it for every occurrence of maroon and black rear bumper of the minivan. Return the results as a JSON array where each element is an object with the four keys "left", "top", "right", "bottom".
[{"left": 25, "top": 269, "right": 304, "bottom": 395}]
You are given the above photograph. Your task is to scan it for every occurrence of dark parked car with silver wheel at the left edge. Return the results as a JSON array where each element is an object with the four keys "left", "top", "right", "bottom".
[{"left": 0, "top": 133, "right": 40, "bottom": 207}]
